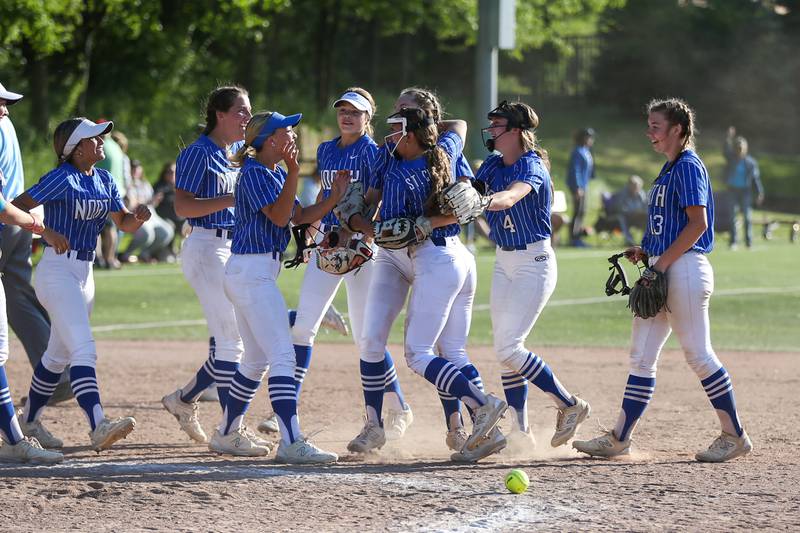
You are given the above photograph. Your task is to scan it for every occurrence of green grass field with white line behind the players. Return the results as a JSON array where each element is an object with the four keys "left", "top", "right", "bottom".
[{"left": 83, "top": 233, "right": 800, "bottom": 351}]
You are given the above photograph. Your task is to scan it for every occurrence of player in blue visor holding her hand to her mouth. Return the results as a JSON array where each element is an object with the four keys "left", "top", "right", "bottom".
[{"left": 216, "top": 112, "right": 350, "bottom": 463}]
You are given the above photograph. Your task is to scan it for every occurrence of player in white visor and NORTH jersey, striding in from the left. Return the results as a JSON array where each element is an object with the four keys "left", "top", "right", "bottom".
[{"left": 14, "top": 118, "right": 150, "bottom": 451}]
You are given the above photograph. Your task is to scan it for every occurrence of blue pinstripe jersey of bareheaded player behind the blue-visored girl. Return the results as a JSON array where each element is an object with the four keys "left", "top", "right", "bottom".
[{"left": 175, "top": 135, "right": 242, "bottom": 230}]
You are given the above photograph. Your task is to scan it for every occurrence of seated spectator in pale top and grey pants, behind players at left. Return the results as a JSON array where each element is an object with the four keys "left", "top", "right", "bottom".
[{"left": 120, "top": 160, "right": 175, "bottom": 262}]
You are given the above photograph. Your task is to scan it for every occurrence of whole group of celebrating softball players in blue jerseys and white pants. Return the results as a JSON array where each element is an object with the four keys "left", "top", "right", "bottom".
[{"left": 0, "top": 76, "right": 752, "bottom": 464}]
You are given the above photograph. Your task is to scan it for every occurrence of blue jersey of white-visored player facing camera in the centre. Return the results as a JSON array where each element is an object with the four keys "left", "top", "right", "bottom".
[{"left": 317, "top": 135, "right": 378, "bottom": 225}]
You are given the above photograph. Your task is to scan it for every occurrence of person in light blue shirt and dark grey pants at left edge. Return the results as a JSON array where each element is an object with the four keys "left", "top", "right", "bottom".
[{"left": 0, "top": 84, "right": 72, "bottom": 403}]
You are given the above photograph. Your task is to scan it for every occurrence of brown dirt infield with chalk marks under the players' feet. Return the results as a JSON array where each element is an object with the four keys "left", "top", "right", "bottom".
[{"left": 0, "top": 342, "right": 800, "bottom": 532}]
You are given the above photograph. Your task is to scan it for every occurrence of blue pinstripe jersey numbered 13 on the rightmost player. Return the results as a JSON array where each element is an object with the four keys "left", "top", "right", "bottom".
[{"left": 642, "top": 150, "right": 714, "bottom": 256}]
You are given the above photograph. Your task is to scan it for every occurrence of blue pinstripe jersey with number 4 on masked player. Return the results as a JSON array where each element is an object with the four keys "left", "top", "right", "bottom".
[{"left": 475, "top": 151, "right": 552, "bottom": 246}]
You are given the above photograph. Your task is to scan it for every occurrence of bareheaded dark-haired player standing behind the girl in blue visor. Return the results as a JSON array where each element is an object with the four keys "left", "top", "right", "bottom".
[{"left": 161, "top": 87, "right": 252, "bottom": 442}]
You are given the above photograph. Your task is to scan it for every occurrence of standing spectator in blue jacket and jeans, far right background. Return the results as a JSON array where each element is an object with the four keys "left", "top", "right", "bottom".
[{"left": 725, "top": 137, "right": 764, "bottom": 249}]
